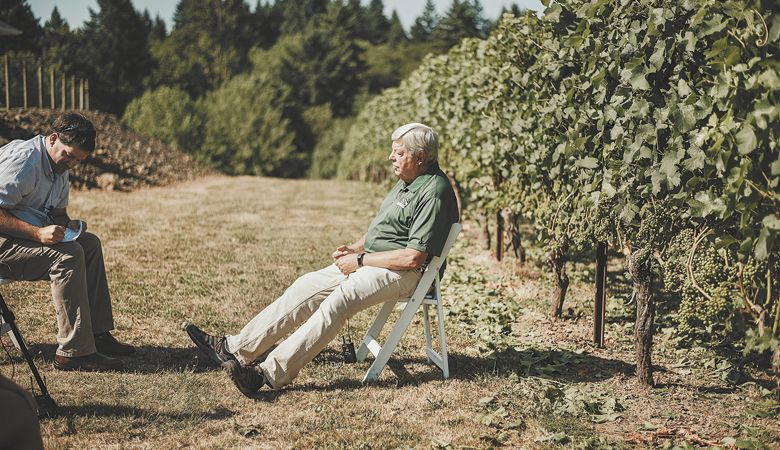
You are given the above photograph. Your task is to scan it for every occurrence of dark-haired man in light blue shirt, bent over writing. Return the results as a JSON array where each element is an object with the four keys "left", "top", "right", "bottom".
[{"left": 0, "top": 113, "right": 133, "bottom": 370}]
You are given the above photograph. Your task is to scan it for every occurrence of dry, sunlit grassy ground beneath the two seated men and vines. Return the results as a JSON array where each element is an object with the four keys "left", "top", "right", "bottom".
[{"left": 0, "top": 177, "right": 780, "bottom": 449}]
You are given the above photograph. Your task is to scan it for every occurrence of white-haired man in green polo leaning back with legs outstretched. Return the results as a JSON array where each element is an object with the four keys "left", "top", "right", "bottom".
[{"left": 184, "top": 123, "right": 458, "bottom": 396}]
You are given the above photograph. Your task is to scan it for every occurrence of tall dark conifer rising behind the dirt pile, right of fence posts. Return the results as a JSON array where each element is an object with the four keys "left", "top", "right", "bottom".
[{"left": 78, "top": 0, "right": 152, "bottom": 114}]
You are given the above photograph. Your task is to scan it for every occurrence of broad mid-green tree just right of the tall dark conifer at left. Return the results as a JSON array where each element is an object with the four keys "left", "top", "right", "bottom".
[{"left": 149, "top": 0, "right": 254, "bottom": 98}]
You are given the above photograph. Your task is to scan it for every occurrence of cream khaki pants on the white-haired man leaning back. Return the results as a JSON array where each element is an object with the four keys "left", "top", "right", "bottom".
[{"left": 227, "top": 264, "right": 421, "bottom": 388}]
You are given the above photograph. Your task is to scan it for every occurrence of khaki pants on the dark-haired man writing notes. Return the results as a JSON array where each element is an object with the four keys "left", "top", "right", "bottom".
[{"left": 0, "top": 233, "right": 114, "bottom": 356}]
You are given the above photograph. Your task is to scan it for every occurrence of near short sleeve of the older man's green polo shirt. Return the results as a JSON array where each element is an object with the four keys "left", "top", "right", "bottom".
[{"left": 406, "top": 196, "right": 452, "bottom": 256}]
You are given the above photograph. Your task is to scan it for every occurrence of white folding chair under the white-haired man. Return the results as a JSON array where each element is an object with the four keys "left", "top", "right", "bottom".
[{"left": 357, "top": 223, "right": 461, "bottom": 383}]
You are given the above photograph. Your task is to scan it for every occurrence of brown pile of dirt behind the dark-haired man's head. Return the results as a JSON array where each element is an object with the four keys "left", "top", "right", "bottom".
[{"left": 0, "top": 109, "right": 210, "bottom": 191}]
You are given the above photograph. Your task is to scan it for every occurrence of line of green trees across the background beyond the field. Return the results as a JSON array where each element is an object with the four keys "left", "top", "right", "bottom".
[{"left": 0, "top": 0, "right": 519, "bottom": 177}]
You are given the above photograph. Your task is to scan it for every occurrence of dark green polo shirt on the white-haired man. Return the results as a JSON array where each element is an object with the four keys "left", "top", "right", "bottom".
[{"left": 364, "top": 165, "right": 458, "bottom": 257}]
